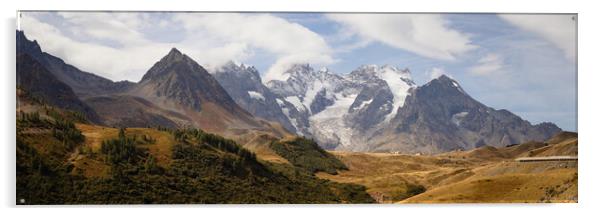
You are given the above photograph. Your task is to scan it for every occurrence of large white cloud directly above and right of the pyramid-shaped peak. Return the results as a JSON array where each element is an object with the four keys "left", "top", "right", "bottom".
[{"left": 174, "top": 13, "right": 334, "bottom": 82}]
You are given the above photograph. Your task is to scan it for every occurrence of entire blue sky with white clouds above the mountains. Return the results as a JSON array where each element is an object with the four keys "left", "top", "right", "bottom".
[{"left": 19, "top": 12, "right": 577, "bottom": 131}]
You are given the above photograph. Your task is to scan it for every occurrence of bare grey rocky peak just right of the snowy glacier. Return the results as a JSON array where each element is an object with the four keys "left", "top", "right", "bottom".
[{"left": 373, "top": 75, "right": 561, "bottom": 153}]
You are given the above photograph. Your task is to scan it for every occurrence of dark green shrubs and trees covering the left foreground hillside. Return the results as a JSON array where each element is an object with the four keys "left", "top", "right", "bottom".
[{"left": 16, "top": 122, "right": 374, "bottom": 204}]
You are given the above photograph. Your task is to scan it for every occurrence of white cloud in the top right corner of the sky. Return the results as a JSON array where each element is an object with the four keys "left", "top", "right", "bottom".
[{"left": 499, "top": 14, "right": 577, "bottom": 60}]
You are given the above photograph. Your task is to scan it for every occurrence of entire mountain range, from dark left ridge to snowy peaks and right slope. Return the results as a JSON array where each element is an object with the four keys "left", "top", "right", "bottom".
[{"left": 17, "top": 31, "right": 561, "bottom": 153}]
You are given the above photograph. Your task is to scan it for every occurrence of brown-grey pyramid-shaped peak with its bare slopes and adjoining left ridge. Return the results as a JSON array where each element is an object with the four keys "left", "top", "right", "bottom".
[{"left": 17, "top": 31, "right": 288, "bottom": 141}]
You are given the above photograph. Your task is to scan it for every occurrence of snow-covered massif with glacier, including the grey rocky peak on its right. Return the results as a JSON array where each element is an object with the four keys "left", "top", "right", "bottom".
[{"left": 252, "top": 64, "right": 561, "bottom": 153}]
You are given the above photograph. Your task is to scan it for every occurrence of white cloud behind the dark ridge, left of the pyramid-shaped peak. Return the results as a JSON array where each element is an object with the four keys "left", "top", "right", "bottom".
[{"left": 20, "top": 12, "right": 173, "bottom": 81}]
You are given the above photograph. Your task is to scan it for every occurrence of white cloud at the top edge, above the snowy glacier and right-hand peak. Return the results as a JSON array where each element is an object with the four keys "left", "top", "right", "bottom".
[{"left": 326, "top": 14, "right": 477, "bottom": 60}]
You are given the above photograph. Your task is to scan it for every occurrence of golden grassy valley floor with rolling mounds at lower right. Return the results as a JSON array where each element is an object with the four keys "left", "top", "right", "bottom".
[{"left": 317, "top": 133, "right": 578, "bottom": 203}]
